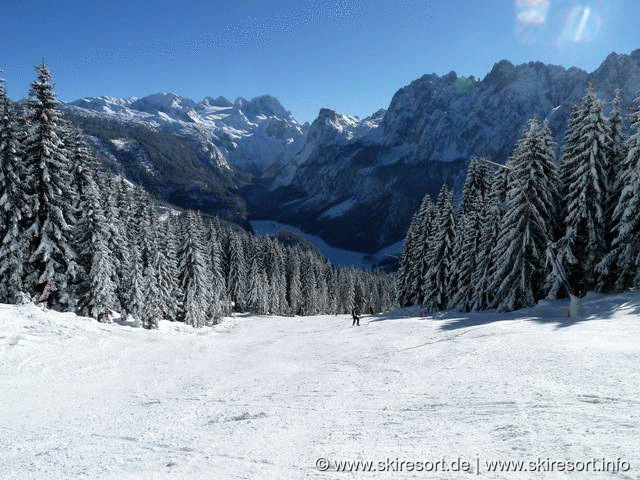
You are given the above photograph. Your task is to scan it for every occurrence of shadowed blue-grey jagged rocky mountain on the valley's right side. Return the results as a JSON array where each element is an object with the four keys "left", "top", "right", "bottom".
[{"left": 262, "top": 50, "right": 640, "bottom": 251}]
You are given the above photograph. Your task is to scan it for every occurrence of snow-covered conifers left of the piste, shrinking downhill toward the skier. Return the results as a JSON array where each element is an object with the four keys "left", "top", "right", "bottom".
[{"left": 0, "top": 64, "right": 397, "bottom": 328}]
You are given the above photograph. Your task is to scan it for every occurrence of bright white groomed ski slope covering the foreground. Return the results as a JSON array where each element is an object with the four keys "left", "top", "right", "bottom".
[{"left": 0, "top": 294, "right": 640, "bottom": 480}]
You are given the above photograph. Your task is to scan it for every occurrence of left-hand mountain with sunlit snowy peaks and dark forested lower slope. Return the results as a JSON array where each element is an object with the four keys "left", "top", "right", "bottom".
[{"left": 62, "top": 93, "right": 307, "bottom": 225}]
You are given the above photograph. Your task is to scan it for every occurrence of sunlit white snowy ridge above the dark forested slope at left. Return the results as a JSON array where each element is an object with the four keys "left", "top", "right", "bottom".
[{"left": 64, "top": 93, "right": 305, "bottom": 172}]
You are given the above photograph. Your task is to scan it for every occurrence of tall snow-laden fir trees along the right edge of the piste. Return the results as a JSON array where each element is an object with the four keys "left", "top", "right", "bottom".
[{"left": 398, "top": 88, "right": 640, "bottom": 311}]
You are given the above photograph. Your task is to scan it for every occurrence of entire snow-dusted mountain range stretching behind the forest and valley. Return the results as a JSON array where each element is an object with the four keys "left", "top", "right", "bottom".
[{"left": 64, "top": 50, "right": 640, "bottom": 252}]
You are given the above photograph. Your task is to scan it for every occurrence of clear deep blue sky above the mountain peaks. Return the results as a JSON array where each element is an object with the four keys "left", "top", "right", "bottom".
[{"left": 0, "top": 0, "right": 640, "bottom": 121}]
